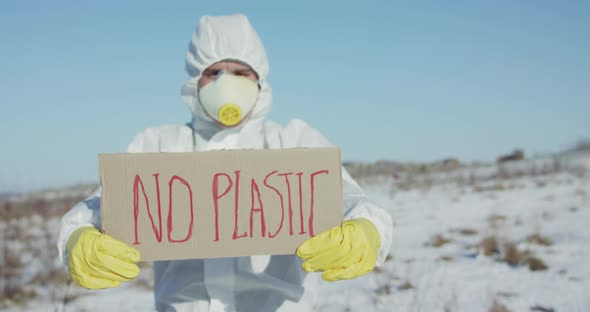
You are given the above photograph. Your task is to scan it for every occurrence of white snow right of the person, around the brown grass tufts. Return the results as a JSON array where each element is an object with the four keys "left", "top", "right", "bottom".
[{"left": 322, "top": 175, "right": 590, "bottom": 312}]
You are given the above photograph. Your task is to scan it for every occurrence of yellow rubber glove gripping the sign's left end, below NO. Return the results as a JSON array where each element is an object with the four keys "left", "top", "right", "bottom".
[{"left": 66, "top": 227, "right": 140, "bottom": 289}]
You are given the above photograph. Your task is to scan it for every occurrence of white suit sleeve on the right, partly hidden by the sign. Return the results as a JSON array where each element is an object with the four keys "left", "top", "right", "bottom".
[{"left": 281, "top": 119, "right": 393, "bottom": 265}]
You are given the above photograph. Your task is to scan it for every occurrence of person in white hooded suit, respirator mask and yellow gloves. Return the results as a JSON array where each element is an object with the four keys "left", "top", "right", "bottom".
[{"left": 58, "top": 15, "right": 392, "bottom": 311}]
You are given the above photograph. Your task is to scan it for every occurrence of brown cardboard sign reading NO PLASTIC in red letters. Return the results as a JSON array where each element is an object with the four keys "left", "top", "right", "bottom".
[{"left": 99, "top": 148, "right": 343, "bottom": 260}]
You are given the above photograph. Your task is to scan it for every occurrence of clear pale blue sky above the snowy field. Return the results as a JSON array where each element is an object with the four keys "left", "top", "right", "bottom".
[{"left": 0, "top": 0, "right": 590, "bottom": 191}]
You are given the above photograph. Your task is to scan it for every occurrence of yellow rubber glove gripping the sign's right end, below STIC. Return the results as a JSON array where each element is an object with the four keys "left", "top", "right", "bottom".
[{"left": 297, "top": 219, "right": 381, "bottom": 282}]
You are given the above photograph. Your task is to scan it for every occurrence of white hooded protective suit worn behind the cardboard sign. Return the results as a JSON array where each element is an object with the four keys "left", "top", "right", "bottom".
[{"left": 58, "top": 15, "right": 392, "bottom": 311}]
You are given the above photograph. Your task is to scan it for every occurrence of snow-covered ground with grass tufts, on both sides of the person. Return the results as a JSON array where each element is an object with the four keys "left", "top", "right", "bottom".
[{"left": 7, "top": 155, "right": 590, "bottom": 312}]
